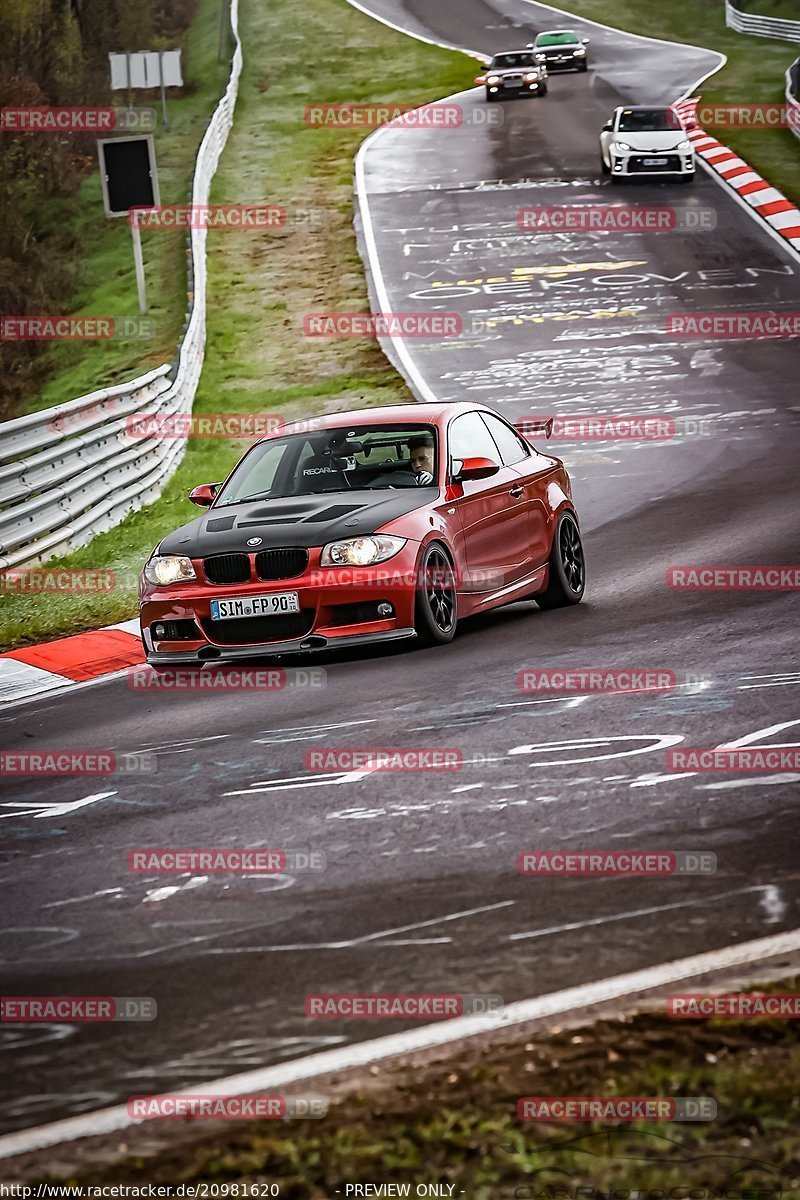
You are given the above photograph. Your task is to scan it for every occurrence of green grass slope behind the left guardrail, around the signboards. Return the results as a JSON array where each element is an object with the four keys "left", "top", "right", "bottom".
[{"left": 17, "top": 0, "right": 230, "bottom": 422}]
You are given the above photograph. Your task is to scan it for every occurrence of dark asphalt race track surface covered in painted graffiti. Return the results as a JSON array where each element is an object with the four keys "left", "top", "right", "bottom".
[{"left": 0, "top": 0, "right": 800, "bottom": 1130}]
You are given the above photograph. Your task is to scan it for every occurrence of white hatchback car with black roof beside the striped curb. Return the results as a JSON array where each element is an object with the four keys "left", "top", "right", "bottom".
[{"left": 600, "top": 107, "right": 694, "bottom": 184}]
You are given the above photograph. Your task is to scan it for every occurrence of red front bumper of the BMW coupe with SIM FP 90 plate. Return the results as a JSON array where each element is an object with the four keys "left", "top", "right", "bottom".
[{"left": 139, "top": 541, "right": 420, "bottom": 664}]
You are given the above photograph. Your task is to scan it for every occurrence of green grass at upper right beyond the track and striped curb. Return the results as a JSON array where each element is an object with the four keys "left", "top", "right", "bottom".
[{"left": 556, "top": 0, "right": 800, "bottom": 204}]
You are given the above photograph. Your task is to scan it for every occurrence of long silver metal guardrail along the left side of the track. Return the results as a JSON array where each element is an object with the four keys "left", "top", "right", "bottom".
[{"left": 0, "top": 0, "right": 242, "bottom": 570}]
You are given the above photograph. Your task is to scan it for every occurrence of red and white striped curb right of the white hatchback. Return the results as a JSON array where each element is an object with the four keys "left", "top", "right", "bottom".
[{"left": 674, "top": 96, "right": 800, "bottom": 251}]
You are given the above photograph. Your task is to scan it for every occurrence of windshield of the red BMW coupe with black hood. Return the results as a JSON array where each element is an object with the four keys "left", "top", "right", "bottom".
[{"left": 215, "top": 425, "right": 437, "bottom": 509}]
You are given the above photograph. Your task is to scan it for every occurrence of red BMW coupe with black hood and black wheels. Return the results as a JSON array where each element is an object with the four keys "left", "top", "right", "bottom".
[{"left": 139, "top": 403, "right": 585, "bottom": 666}]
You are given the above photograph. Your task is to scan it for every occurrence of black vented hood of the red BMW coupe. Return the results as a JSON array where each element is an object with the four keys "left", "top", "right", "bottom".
[{"left": 154, "top": 487, "right": 438, "bottom": 558}]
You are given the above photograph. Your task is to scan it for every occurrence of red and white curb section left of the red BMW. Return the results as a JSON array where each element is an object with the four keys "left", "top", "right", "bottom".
[{"left": 0, "top": 619, "right": 144, "bottom": 703}]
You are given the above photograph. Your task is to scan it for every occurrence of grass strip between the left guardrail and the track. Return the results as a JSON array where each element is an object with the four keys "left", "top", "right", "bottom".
[{"left": 0, "top": 0, "right": 475, "bottom": 648}]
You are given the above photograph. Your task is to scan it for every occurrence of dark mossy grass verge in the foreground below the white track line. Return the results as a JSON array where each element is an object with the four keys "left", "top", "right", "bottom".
[{"left": 25, "top": 978, "right": 800, "bottom": 1200}]
